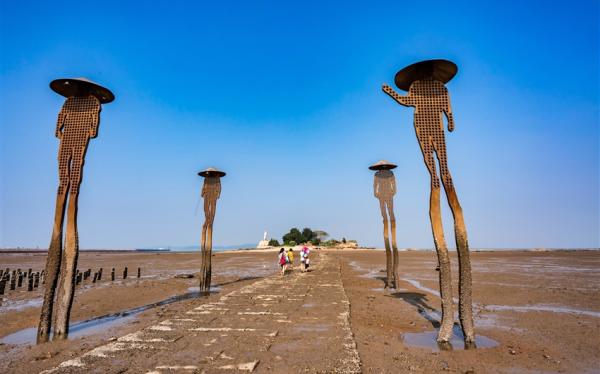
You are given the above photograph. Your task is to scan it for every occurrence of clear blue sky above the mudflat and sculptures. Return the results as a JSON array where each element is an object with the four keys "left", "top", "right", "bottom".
[{"left": 0, "top": 0, "right": 600, "bottom": 248}]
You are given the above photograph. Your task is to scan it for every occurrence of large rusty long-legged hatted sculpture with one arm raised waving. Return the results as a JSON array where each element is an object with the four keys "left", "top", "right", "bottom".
[{"left": 383, "top": 60, "right": 475, "bottom": 348}]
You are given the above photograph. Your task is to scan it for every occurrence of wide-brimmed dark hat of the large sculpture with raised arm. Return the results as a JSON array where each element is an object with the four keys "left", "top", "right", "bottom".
[{"left": 394, "top": 60, "right": 458, "bottom": 91}]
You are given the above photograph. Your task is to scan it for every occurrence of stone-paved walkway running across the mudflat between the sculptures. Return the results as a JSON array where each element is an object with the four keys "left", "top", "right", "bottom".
[{"left": 46, "top": 253, "right": 361, "bottom": 374}]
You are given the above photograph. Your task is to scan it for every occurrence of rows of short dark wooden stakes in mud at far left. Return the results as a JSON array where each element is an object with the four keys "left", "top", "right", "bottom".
[{"left": 0, "top": 267, "right": 142, "bottom": 295}]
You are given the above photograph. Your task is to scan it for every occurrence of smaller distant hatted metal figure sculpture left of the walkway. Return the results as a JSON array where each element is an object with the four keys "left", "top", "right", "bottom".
[{"left": 198, "top": 168, "right": 225, "bottom": 293}]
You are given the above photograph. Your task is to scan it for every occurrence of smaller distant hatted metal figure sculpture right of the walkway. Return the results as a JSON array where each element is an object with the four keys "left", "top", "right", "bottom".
[{"left": 369, "top": 160, "right": 398, "bottom": 289}]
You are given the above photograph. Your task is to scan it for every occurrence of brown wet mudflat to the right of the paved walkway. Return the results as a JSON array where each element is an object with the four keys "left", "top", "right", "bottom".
[{"left": 339, "top": 251, "right": 600, "bottom": 373}]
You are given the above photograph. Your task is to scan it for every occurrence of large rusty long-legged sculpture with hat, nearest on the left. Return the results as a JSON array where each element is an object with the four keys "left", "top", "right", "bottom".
[{"left": 37, "top": 78, "right": 115, "bottom": 343}]
